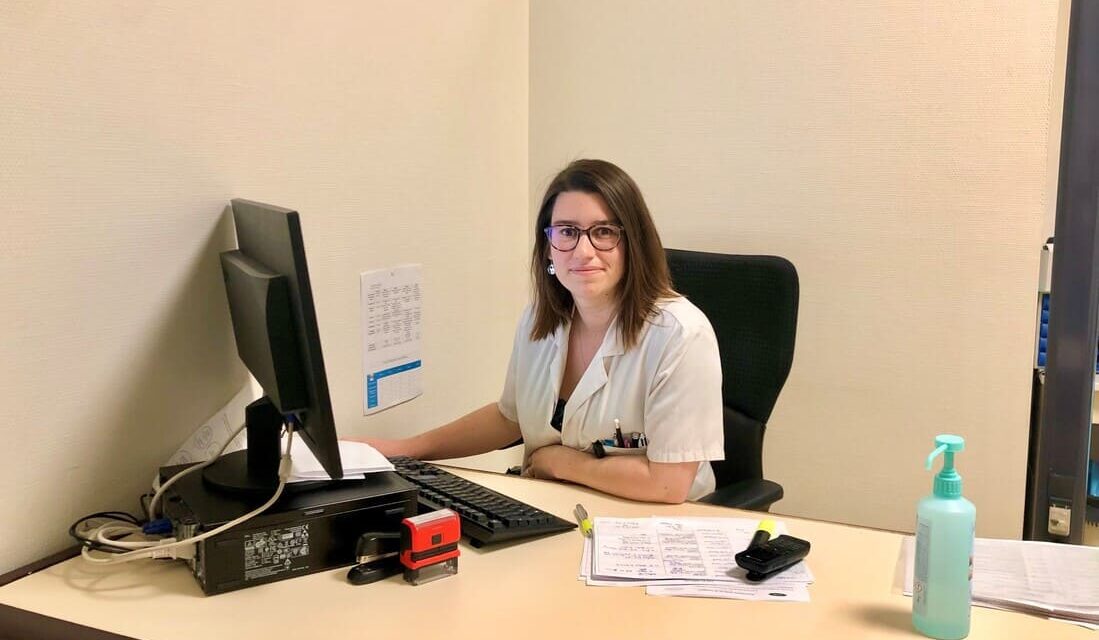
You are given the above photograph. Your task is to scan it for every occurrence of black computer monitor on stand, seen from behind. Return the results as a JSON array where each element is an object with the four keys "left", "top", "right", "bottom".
[{"left": 203, "top": 199, "right": 343, "bottom": 493}]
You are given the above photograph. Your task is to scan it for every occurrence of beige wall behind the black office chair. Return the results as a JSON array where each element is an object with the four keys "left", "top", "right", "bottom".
[{"left": 530, "top": 0, "right": 1064, "bottom": 537}]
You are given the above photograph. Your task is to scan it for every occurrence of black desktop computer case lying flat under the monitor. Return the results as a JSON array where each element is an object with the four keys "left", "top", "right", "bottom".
[{"left": 160, "top": 465, "right": 417, "bottom": 595}]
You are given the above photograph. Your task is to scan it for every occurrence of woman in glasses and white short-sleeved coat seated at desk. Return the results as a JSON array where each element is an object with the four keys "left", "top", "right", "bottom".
[{"left": 366, "top": 159, "right": 724, "bottom": 503}]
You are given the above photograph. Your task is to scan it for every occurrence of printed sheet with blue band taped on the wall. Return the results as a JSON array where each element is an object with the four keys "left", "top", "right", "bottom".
[{"left": 359, "top": 264, "right": 423, "bottom": 416}]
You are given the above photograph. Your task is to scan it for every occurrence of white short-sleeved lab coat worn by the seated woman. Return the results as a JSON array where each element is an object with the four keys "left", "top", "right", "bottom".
[{"left": 499, "top": 298, "right": 724, "bottom": 500}]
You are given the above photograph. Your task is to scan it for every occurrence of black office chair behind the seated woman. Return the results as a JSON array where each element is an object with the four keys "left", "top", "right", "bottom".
[{"left": 667, "top": 249, "right": 798, "bottom": 511}]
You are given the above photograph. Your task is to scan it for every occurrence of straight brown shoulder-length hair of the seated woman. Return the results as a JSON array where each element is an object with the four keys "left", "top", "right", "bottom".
[{"left": 531, "top": 159, "right": 676, "bottom": 349}]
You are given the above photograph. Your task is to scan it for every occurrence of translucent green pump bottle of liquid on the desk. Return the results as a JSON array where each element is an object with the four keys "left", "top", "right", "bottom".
[{"left": 912, "top": 434, "right": 977, "bottom": 640}]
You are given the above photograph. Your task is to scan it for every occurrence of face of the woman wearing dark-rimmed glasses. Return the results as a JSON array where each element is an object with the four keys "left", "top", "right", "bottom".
[{"left": 550, "top": 191, "right": 626, "bottom": 306}]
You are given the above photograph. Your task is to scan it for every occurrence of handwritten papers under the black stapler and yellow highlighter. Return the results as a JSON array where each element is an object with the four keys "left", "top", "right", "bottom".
[{"left": 580, "top": 517, "right": 813, "bottom": 603}]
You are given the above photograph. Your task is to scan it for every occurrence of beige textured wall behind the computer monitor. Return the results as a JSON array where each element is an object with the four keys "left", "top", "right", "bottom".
[{"left": 0, "top": 0, "right": 529, "bottom": 573}]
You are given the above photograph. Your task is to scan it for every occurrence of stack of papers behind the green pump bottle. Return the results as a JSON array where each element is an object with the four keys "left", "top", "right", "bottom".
[{"left": 902, "top": 538, "right": 1099, "bottom": 626}]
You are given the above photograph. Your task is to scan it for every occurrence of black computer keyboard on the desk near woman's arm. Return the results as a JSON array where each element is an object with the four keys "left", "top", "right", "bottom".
[{"left": 389, "top": 456, "right": 576, "bottom": 547}]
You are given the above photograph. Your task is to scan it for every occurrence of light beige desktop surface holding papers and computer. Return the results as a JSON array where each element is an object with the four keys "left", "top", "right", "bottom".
[{"left": 0, "top": 471, "right": 1096, "bottom": 640}]
